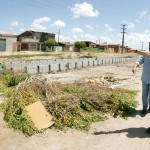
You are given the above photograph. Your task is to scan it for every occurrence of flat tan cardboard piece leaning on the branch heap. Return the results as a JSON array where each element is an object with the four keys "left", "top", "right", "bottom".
[{"left": 26, "top": 101, "right": 54, "bottom": 130}]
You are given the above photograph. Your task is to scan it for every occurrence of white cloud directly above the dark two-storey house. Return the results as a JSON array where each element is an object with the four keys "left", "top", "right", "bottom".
[{"left": 31, "top": 17, "right": 51, "bottom": 30}]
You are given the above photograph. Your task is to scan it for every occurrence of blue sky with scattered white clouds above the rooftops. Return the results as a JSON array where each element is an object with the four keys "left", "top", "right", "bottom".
[{"left": 0, "top": 0, "right": 150, "bottom": 50}]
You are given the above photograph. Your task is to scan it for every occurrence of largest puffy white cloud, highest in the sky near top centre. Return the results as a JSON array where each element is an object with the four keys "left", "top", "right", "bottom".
[{"left": 70, "top": 2, "right": 99, "bottom": 18}]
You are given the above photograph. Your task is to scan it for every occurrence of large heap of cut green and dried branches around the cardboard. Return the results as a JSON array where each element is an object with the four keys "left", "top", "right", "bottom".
[{"left": 0, "top": 70, "right": 137, "bottom": 136}]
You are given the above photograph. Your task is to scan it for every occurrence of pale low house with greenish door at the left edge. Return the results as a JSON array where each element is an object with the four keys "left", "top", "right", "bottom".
[{"left": 0, "top": 34, "right": 17, "bottom": 52}]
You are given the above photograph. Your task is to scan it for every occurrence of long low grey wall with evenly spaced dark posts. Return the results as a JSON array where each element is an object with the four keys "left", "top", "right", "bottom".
[{"left": 3, "top": 57, "right": 136, "bottom": 74}]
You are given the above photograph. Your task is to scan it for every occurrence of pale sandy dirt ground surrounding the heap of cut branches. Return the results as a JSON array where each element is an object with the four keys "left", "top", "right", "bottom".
[{"left": 0, "top": 62, "right": 150, "bottom": 150}]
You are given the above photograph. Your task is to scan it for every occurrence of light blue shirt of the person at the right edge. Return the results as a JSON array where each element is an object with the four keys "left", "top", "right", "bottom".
[{"left": 136, "top": 56, "right": 150, "bottom": 84}]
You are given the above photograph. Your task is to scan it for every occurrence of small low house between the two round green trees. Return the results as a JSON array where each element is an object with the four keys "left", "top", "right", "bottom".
[{"left": 59, "top": 42, "right": 74, "bottom": 51}]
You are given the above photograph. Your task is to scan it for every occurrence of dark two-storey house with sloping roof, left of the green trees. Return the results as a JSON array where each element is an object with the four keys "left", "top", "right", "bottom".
[{"left": 17, "top": 30, "right": 55, "bottom": 51}]
